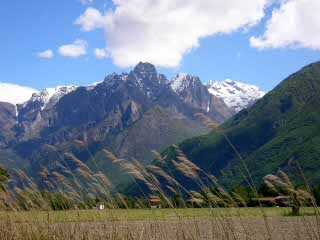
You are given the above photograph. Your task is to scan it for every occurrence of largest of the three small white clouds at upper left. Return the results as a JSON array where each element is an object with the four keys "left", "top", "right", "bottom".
[{"left": 59, "top": 39, "right": 88, "bottom": 58}]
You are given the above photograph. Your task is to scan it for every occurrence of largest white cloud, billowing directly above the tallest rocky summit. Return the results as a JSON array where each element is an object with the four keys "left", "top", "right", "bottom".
[{"left": 76, "top": 0, "right": 273, "bottom": 67}]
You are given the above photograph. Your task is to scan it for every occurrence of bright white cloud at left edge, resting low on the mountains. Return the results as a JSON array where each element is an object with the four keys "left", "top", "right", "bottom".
[{"left": 0, "top": 82, "right": 38, "bottom": 104}]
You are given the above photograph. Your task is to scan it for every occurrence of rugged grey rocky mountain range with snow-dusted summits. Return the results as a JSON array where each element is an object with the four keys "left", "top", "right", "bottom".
[{"left": 0, "top": 63, "right": 263, "bottom": 193}]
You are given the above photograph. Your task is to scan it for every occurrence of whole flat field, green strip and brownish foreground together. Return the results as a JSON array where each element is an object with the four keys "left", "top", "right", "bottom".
[{"left": 0, "top": 208, "right": 320, "bottom": 240}]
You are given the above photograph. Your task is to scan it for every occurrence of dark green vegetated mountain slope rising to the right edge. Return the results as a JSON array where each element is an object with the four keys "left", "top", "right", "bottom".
[{"left": 164, "top": 63, "right": 320, "bottom": 188}]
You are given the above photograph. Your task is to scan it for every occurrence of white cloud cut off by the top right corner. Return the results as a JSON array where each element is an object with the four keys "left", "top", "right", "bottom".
[{"left": 250, "top": 0, "right": 320, "bottom": 50}]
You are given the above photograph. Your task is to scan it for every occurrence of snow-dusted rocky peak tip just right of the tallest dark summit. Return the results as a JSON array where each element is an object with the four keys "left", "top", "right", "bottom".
[{"left": 170, "top": 73, "right": 201, "bottom": 93}]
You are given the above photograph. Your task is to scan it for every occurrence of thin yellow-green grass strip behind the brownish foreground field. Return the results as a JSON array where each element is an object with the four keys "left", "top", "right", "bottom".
[{"left": 0, "top": 208, "right": 314, "bottom": 224}]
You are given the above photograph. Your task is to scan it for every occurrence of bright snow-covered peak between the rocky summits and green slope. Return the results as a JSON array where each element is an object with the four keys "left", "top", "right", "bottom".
[{"left": 207, "top": 79, "right": 265, "bottom": 112}]
